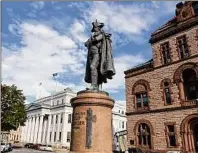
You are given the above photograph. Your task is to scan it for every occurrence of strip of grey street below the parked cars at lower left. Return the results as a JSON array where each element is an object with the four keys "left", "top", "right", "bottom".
[{"left": 9, "top": 148, "right": 67, "bottom": 153}]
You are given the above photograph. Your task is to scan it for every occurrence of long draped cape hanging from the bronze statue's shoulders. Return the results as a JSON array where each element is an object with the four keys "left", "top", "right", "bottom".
[{"left": 85, "top": 32, "right": 116, "bottom": 85}]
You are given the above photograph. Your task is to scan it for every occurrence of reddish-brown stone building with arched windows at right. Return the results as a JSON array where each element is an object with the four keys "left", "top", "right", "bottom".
[{"left": 125, "top": 2, "right": 198, "bottom": 152}]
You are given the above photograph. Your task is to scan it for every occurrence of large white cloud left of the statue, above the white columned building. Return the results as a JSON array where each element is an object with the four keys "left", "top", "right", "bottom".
[{"left": 2, "top": 23, "right": 85, "bottom": 100}]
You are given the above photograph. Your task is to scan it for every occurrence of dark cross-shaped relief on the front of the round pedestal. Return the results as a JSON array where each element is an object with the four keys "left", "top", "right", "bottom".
[{"left": 86, "top": 108, "right": 96, "bottom": 148}]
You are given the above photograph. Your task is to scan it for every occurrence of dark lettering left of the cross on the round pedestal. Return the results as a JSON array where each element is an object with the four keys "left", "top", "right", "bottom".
[{"left": 72, "top": 112, "right": 86, "bottom": 130}]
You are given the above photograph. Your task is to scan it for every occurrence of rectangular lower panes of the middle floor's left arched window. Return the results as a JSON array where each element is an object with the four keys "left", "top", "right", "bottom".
[{"left": 136, "top": 93, "right": 148, "bottom": 108}]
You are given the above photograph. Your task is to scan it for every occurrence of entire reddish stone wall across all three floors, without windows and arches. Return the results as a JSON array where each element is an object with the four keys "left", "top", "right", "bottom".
[{"left": 125, "top": 11, "right": 198, "bottom": 150}]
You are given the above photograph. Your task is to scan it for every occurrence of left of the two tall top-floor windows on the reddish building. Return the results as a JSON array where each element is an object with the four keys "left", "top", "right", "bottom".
[{"left": 161, "top": 42, "right": 171, "bottom": 64}]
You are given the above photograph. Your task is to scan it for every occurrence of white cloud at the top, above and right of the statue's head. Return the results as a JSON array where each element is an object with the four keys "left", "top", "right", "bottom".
[{"left": 82, "top": 2, "right": 156, "bottom": 36}]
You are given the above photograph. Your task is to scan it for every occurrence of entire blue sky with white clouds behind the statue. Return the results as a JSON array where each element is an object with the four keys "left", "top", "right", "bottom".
[{"left": 2, "top": 1, "right": 177, "bottom": 103}]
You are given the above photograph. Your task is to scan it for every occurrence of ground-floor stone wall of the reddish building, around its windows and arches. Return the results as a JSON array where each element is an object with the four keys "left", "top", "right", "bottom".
[{"left": 127, "top": 108, "right": 198, "bottom": 150}]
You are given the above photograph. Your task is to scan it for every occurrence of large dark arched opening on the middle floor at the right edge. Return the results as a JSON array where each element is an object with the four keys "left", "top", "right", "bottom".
[{"left": 182, "top": 69, "right": 198, "bottom": 100}]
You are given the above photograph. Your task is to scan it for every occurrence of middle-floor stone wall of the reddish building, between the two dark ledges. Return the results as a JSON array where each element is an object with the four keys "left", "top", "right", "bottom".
[{"left": 125, "top": 57, "right": 198, "bottom": 112}]
